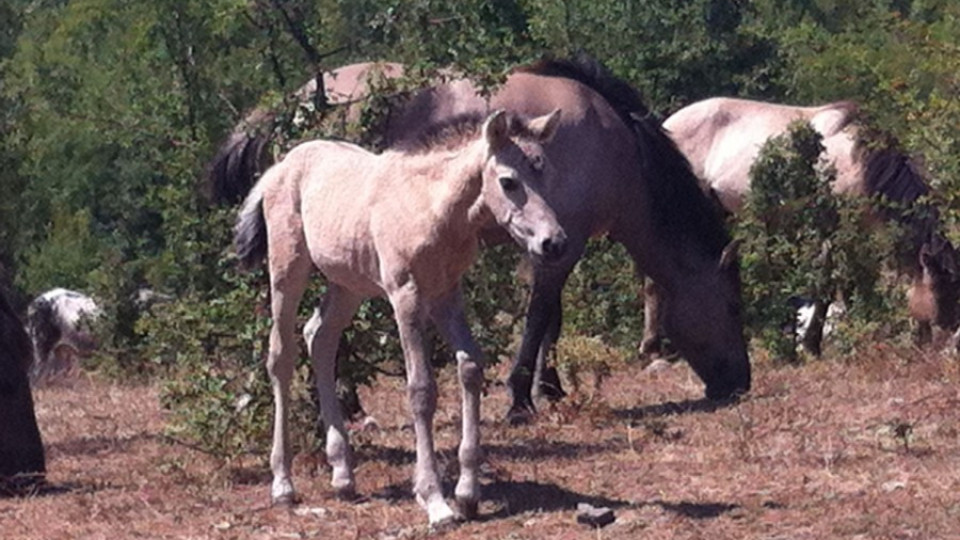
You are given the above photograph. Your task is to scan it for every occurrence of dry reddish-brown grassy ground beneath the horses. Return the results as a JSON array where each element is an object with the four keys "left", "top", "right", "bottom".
[{"left": 0, "top": 346, "right": 960, "bottom": 540}]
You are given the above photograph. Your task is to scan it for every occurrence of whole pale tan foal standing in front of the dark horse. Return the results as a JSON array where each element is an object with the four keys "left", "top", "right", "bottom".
[{"left": 235, "top": 110, "right": 566, "bottom": 525}]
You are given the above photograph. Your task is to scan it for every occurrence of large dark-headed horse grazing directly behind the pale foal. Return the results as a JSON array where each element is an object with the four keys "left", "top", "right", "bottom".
[{"left": 209, "top": 57, "right": 750, "bottom": 420}]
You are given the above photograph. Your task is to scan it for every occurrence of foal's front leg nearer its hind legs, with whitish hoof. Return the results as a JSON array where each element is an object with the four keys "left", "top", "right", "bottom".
[{"left": 389, "top": 282, "right": 456, "bottom": 526}]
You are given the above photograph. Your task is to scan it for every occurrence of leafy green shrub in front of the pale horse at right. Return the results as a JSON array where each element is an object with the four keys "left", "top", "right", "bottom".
[{"left": 734, "top": 122, "right": 894, "bottom": 361}]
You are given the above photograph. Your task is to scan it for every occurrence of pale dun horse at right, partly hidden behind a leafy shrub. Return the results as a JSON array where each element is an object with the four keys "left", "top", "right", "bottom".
[{"left": 644, "top": 98, "right": 960, "bottom": 346}]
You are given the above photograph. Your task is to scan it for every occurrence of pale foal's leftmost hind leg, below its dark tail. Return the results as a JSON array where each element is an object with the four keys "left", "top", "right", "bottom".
[{"left": 267, "top": 232, "right": 313, "bottom": 504}]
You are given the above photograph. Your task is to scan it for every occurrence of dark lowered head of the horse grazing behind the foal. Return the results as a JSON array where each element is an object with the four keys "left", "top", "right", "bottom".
[{"left": 662, "top": 241, "right": 750, "bottom": 399}]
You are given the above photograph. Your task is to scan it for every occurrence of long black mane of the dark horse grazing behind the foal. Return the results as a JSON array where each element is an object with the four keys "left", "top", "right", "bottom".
[{"left": 517, "top": 53, "right": 730, "bottom": 257}]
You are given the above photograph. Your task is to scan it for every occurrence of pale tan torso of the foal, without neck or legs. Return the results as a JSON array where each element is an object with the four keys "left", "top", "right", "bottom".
[{"left": 263, "top": 140, "right": 484, "bottom": 297}]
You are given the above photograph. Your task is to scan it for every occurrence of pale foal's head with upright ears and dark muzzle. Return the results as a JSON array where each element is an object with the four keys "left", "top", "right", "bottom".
[{"left": 481, "top": 109, "right": 567, "bottom": 262}]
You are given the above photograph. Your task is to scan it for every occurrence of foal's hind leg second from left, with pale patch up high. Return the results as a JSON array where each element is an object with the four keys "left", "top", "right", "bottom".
[{"left": 303, "top": 283, "right": 363, "bottom": 498}]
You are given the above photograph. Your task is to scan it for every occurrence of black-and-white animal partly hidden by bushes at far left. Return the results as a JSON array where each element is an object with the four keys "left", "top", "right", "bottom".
[{"left": 27, "top": 288, "right": 101, "bottom": 381}]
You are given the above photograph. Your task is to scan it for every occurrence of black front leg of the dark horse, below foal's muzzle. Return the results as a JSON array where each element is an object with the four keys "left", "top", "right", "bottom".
[{"left": 507, "top": 255, "right": 583, "bottom": 424}]
